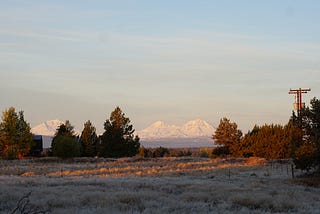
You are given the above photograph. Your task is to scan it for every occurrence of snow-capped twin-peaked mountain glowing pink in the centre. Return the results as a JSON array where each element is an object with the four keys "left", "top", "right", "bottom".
[{"left": 137, "top": 119, "right": 214, "bottom": 140}]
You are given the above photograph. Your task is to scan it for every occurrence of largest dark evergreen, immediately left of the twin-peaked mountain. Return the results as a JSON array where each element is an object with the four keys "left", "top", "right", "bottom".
[{"left": 99, "top": 107, "right": 140, "bottom": 157}]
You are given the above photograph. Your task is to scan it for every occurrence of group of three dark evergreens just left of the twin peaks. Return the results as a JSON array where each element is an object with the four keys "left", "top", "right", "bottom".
[{"left": 51, "top": 107, "right": 140, "bottom": 158}]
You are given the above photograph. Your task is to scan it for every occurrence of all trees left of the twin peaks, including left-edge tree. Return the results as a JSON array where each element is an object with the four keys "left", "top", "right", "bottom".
[{"left": 0, "top": 107, "right": 140, "bottom": 159}]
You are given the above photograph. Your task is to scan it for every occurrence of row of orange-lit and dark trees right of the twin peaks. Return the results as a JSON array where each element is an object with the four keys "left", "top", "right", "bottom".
[{"left": 212, "top": 98, "right": 320, "bottom": 171}]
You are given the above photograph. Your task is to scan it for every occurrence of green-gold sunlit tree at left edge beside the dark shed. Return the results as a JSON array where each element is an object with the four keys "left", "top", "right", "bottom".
[{"left": 0, "top": 107, "right": 33, "bottom": 159}]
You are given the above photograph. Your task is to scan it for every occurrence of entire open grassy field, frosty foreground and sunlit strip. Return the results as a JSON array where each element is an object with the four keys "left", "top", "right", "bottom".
[{"left": 0, "top": 157, "right": 320, "bottom": 213}]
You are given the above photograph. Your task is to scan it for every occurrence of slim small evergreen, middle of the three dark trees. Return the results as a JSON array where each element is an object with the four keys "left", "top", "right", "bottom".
[{"left": 80, "top": 120, "right": 98, "bottom": 157}]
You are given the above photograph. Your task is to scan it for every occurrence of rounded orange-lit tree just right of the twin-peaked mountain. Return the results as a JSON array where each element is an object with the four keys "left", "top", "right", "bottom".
[{"left": 212, "top": 117, "right": 242, "bottom": 155}]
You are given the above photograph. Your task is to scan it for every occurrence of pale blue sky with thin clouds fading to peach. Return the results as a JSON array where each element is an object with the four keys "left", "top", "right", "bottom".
[{"left": 0, "top": 0, "right": 320, "bottom": 132}]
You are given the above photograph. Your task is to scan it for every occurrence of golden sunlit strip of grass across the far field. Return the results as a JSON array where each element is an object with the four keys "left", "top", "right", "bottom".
[{"left": 1, "top": 158, "right": 266, "bottom": 177}]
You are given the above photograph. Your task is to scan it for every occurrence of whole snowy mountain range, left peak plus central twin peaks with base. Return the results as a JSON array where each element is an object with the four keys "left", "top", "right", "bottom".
[{"left": 31, "top": 119, "right": 215, "bottom": 148}]
